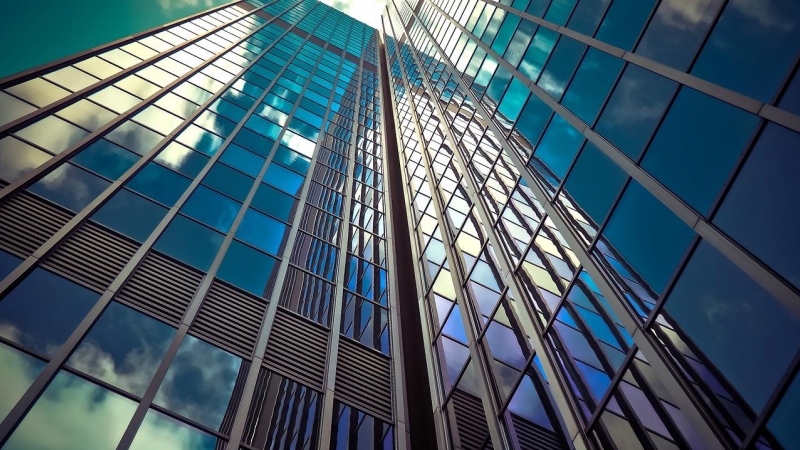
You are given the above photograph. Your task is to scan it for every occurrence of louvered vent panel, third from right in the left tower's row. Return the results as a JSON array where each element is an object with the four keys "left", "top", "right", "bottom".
[{"left": 190, "top": 280, "right": 267, "bottom": 358}]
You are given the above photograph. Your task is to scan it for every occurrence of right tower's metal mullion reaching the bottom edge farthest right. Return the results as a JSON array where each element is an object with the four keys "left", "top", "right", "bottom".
[{"left": 404, "top": 1, "right": 721, "bottom": 448}]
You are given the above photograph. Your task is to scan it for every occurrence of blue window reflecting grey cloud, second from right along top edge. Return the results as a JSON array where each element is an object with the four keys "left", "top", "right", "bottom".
[{"left": 636, "top": 0, "right": 723, "bottom": 70}]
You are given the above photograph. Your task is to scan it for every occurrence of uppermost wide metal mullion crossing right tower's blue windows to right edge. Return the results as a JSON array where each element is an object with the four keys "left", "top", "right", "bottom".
[{"left": 482, "top": 0, "right": 800, "bottom": 132}]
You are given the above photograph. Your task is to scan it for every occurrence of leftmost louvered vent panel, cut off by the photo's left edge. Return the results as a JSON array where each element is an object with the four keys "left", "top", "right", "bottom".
[{"left": 0, "top": 192, "right": 73, "bottom": 256}]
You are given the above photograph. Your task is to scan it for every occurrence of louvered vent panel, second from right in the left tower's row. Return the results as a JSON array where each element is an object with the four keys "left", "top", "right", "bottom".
[{"left": 264, "top": 308, "right": 328, "bottom": 389}]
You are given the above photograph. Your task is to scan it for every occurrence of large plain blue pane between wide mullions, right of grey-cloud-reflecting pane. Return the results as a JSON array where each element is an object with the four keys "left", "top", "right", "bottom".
[{"left": 642, "top": 88, "right": 758, "bottom": 213}]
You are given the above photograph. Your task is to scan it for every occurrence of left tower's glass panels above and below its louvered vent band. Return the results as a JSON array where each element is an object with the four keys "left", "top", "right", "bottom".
[{"left": 0, "top": 0, "right": 395, "bottom": 449}]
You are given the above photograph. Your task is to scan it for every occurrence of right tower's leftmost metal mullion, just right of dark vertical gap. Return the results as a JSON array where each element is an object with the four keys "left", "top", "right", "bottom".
[{"left": 381, "top": 27, "right": 447, "bottom": 449}]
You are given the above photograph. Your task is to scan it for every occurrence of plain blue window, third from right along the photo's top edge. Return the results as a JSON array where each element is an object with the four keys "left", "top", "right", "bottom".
[{"left": 595, "top": 0, "right": 656, "bottom": 51}]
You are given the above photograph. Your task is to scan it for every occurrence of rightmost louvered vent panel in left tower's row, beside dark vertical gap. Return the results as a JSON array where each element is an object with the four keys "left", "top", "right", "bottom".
[{"left": 336, "top": 336, "right": 392, "bottom": 422}]
